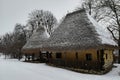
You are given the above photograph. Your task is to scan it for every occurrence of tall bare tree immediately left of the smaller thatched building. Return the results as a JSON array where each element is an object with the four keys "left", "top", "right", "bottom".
[{"left": 13, "top": 23, "right": 27, "bottom": 59}]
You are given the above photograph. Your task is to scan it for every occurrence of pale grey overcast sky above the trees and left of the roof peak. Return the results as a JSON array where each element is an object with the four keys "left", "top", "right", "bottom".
[{"left": 0, "top": 0, "right": 81, "bottom": 35}]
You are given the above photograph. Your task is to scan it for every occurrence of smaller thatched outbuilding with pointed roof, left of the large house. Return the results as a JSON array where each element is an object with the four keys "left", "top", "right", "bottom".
[{"left": 22, "top": 23, "right": 50, "bottom": 62}]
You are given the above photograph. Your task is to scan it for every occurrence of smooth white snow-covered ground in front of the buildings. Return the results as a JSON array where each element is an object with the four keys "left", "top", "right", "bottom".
[{"left": 0, "top": 57, "right": 120, "bottom": 80}]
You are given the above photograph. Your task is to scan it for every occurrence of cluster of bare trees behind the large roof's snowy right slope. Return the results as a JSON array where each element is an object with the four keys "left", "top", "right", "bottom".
[{"left": 83, "top": 0, "right": 120, "bottom": 63}]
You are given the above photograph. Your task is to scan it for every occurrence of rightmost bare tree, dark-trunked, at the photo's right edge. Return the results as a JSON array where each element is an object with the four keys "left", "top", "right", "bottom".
[{"left": 101, "top": 0, "right": 120, "bottom": 63}]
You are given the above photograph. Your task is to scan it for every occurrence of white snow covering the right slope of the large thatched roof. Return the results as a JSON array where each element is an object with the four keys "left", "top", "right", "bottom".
[{"left": 87, "top": 13, "right": 117, "bottom": 45}]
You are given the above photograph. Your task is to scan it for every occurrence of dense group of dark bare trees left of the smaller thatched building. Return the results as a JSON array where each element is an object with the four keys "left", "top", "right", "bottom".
[{"left": 0, "top": 23, "right": 26, "bottom": 59}]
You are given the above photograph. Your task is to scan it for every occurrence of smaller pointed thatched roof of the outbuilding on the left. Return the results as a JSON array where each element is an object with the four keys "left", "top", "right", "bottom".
[{"left": 23, "top": 26, "right": 50, "bottom": 49}]
